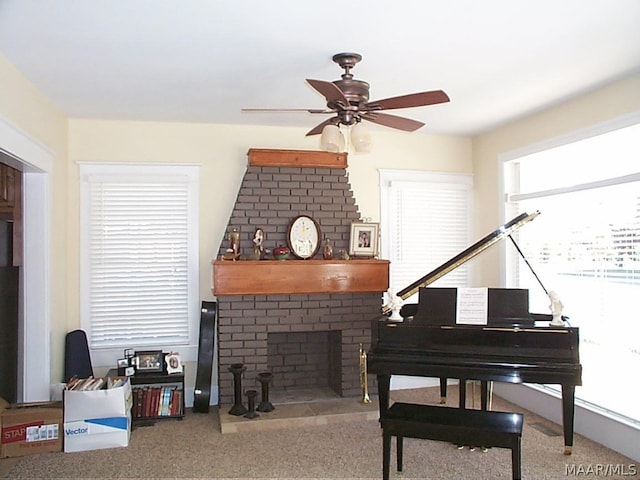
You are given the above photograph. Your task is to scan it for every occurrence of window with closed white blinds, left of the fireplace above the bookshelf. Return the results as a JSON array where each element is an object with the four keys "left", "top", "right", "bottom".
[{"left": 80, "top": 164, "right": 199, "bottom": 365}]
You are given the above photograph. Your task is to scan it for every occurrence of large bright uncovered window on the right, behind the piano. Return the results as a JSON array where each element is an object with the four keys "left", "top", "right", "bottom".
[{"left": 504, "top": 120, "right": 640, "bottom": 422}]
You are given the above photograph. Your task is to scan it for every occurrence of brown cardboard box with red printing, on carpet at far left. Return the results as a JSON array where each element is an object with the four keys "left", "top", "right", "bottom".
[{"left": 0, "top": 398, "right": 63, "bottom": 458}]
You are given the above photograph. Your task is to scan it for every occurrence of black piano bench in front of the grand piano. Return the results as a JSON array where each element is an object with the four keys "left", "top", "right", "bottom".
[{"left": 380, "top": 402, "right": 523, "bottom": 480}]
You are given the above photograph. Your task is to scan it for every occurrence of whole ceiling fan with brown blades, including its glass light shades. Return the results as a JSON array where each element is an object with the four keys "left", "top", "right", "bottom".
[{"left": 243, "top": 53, "right": 449, "bottom": 152}]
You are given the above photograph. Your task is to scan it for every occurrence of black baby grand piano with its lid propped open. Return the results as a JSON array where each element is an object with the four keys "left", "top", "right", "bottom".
[{"left": 367, "top": 212, "right": 582, "bottom": 455}]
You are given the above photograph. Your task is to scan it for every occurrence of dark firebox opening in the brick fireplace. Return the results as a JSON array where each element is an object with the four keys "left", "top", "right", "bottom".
[{"left": 267, "top": 330, "right": 342, "bottom": 401}]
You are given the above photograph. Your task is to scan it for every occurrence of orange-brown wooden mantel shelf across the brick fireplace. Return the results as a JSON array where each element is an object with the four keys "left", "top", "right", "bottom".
[{"left": 213, "top": 259, "right": 389, "bottom": 296}]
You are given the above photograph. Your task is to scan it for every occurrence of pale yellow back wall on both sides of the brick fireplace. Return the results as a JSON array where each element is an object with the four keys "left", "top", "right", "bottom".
[{"left": 68, "top": 119, "right": 471, "bottom": 383}]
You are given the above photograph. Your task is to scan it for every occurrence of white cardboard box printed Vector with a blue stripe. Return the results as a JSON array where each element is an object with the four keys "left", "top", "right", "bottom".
[{"left": 64, "top": 379, "right": 132, "bottom": 452}]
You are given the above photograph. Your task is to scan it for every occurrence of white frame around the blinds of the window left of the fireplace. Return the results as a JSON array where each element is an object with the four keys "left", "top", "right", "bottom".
[{"left": 78, "top": 162, "right": 200, "bottom": 367}]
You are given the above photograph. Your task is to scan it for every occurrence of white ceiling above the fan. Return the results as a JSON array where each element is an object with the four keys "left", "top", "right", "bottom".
[{"left": 0, "top": 0, "right": 640, "bottom": 135}]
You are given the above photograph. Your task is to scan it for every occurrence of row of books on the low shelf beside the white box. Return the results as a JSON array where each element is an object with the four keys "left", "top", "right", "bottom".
[{"left": 131, "top": 384, "right": 184, "bottom": 418}]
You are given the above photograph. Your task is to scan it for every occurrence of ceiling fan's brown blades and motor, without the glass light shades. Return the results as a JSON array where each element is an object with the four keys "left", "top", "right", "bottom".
[{"left": 242, "top": 53, "right": 449, "bottom": 136}]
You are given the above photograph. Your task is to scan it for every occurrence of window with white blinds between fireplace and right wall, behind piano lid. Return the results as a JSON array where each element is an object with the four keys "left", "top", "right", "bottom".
[{"left": 380, "top": 170, "right": 473, "bottom": 303}]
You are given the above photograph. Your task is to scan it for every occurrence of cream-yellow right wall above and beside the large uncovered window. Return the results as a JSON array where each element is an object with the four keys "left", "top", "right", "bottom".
[{"left": 473, "top": 74, "right": 640, "bottom": 286}]
